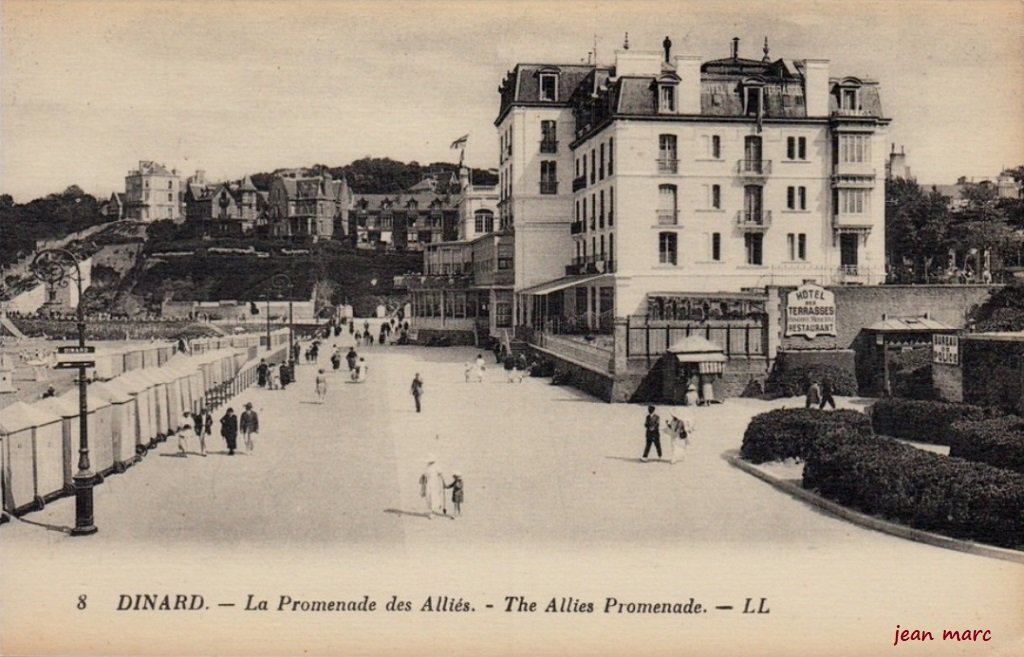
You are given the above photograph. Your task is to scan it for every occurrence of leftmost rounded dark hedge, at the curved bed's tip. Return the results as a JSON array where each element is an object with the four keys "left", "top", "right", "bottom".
[{"left": 739, "top": 408, "right": 871, "bottom": 464}]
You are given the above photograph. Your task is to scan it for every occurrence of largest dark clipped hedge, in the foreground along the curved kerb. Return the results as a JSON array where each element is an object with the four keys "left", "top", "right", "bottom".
[{"left": 803, "top": 429, "right": 1024, "bottom": 549}]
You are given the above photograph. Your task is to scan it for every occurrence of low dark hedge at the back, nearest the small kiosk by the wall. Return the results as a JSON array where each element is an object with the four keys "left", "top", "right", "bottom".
[{"left": 869, "top": 398, "right": 1002, "bottom": 445}]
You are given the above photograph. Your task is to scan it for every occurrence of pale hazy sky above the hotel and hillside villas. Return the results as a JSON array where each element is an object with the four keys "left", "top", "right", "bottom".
[{"left": 0, "top": 0, "right": 1024, "bottom": 202}]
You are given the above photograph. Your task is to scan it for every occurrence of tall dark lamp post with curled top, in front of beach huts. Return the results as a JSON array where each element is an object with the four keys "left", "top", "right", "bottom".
[{"left": 29, "top": 249, "right": 97, "bottom": 536}]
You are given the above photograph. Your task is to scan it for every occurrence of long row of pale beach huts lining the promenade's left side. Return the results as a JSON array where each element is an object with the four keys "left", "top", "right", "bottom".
[{"left": 0, "top": 330, "right": 289, "bottom": 516}]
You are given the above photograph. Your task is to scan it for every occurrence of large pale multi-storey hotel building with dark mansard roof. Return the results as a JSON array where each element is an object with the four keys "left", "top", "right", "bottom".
[{"left": 495, "top": 39, "right": 889, "bottom": 333}]
